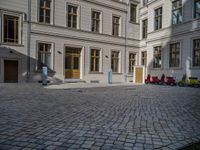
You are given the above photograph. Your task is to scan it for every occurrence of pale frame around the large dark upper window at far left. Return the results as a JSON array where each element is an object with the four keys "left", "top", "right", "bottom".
[{"left": 1, "top": 11, "right": 23, "bottom": 45}]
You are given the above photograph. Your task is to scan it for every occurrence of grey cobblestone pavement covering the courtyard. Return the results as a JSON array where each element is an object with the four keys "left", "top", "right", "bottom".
[{"left": 0, "top": 84, "right": 200, "bottom": 150}]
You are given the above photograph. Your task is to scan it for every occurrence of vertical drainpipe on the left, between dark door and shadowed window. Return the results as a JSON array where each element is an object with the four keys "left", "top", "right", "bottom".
[{"left": 27, "top": 0, "right": 31, "bottom": 81}]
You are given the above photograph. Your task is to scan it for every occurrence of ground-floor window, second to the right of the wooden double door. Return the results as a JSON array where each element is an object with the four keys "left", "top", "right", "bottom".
[{"left": 111, "top": 51, "right": 119, "bottom": 72}]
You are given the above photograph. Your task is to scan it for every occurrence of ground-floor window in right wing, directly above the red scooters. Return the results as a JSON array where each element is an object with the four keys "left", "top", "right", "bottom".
[{"left": 153, "top": 46, "right": 161, "bottom": 68}]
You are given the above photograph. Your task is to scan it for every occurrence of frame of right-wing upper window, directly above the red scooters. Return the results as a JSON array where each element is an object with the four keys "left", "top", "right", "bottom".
[{"left": 154, "top": 6, "right": 163, "bottom": 31}]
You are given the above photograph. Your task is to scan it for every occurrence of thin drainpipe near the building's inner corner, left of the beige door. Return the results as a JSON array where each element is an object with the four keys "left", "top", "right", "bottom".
[{"left": 124, "top": 1, "right": 128, "bottom": 82}]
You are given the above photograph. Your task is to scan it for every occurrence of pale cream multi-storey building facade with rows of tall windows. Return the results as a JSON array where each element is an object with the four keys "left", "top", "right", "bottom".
[{"left": 0, "top": 0, "right": 200, "bottom": 83}]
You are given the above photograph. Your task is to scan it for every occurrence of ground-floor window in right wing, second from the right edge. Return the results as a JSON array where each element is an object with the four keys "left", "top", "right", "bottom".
[{"left": 169, "top": 43, "right": 180, "bottom": 67}]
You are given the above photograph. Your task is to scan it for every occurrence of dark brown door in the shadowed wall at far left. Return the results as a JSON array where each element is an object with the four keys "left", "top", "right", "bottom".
[{"left": 4, "top": 60, "right": 18, "bottom": 83}]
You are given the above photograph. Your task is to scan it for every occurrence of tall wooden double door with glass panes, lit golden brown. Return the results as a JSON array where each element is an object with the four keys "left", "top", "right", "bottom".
[{"left": 65, "top": 47, "right": 81, "bottom": 79}]
